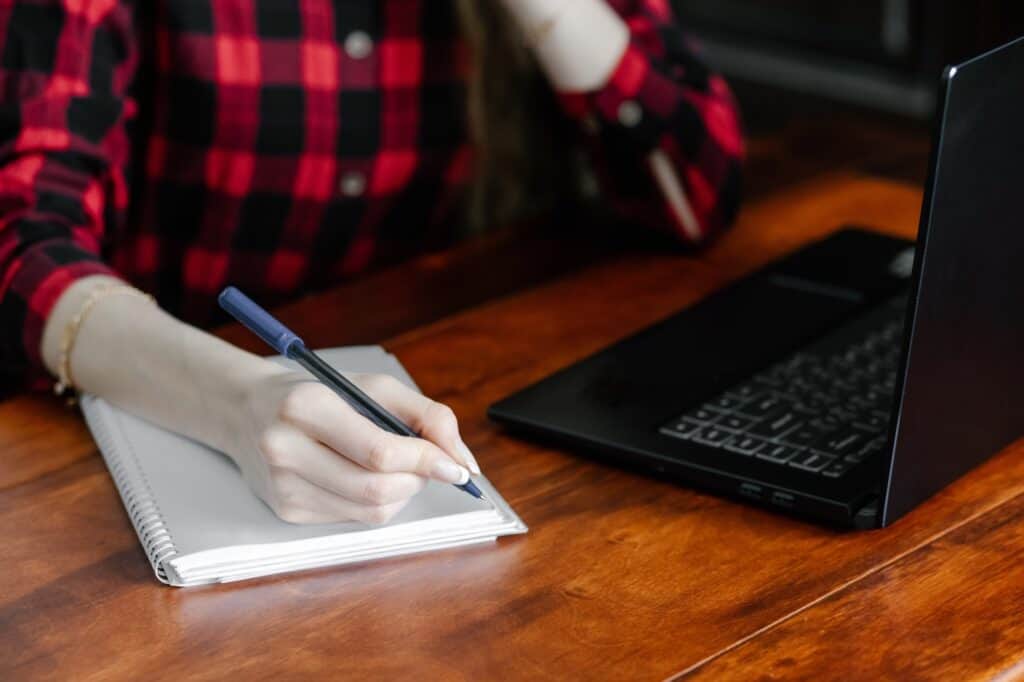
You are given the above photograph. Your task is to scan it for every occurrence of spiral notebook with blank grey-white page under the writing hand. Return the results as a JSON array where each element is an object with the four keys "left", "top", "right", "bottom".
[{"left": 82, "top": 346, "right": 526, "bottom": 587}]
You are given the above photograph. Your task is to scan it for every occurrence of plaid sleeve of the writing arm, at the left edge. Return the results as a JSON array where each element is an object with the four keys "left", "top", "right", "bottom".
[{"left": 0, "top": 0, "right": 136, "bottom": 378}]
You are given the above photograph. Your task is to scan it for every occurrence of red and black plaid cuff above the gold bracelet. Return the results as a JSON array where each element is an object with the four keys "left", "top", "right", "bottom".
[{"left": 0, "top": 240, "right": 117, "bottom": 388}]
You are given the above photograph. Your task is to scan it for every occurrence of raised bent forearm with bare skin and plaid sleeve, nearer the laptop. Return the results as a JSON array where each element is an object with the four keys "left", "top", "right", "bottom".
[{"left": 502, "top": 0, "right": 743, "bottom": 244}]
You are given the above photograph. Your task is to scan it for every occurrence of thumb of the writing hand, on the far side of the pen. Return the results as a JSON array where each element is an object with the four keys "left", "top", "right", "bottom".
[{"left": 352, "top": 374, "right": 480, "bottom": 474}]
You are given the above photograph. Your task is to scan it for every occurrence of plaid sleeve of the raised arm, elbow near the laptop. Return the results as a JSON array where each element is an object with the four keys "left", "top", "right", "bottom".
[{"left": 561, "top": 0, "right": 743, "bottom": 244}]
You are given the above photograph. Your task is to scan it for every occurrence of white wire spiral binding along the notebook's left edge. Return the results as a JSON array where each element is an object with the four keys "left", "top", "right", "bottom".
[{"left": 82, "top": 395, "right": 178, "bottom": 584}]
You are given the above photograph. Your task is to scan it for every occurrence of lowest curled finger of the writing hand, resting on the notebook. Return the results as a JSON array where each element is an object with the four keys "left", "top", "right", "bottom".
[{"left": 270, "top": 471, "right": 409, "bottom": 525}]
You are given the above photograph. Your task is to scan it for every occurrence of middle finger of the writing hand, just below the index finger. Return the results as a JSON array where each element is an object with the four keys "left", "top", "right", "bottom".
[{"left": 263, "top": 425, "right": 426, "bottom": 506}]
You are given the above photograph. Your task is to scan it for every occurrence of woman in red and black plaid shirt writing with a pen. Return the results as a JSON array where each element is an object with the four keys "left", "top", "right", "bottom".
[{"left": 0, "top": 0, "right": 741, "bottom": 522}]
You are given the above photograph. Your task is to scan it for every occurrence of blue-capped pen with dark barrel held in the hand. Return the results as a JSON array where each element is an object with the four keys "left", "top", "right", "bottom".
[{"left": 217, "top": 287, "right": 483, "bottom": 500}]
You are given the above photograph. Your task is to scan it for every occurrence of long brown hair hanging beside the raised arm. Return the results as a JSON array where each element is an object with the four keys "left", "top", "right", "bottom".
[{"left": 457, "top": 0, "right": 574, "bottom": 231}]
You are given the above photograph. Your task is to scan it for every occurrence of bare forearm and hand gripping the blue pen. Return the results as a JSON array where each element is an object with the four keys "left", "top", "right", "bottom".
[{"left": 41, "top": 276, "right": 479, "bottom": 523}]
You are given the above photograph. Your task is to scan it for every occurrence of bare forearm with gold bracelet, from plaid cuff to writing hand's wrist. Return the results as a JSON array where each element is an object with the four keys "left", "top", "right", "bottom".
[{"left": 42, "top": 276, "right": 278, "bottom": 456}]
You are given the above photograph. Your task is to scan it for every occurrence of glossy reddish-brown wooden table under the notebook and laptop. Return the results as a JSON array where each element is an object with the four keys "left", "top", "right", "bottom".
[{"left": 0, "top": 175, "right": 1024, "bottom": 680}]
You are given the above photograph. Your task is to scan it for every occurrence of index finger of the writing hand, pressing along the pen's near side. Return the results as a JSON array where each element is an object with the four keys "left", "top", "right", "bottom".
[{"left": 281, "top": 383, "right": 469, "bottom": 484}]
